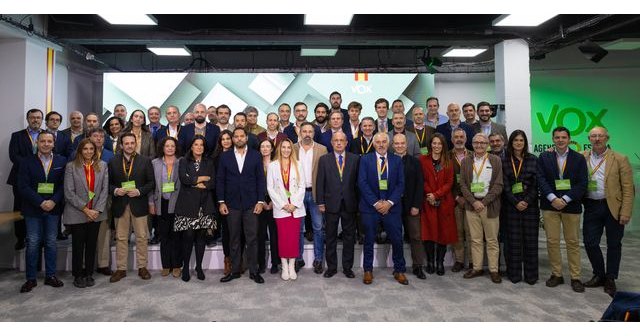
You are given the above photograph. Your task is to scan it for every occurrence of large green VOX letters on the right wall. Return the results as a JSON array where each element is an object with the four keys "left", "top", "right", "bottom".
[{"left": 536, "top": 104, "right": 608, "bottom": 136}]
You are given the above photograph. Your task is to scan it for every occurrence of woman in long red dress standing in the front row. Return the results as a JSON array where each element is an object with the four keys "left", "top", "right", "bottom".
[{"left": 420, "top": 133, "right": 458, "bottom": 275}]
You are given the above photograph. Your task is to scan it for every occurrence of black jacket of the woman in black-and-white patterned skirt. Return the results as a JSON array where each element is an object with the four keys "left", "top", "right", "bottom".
[{"left": 175, "top": 156, "right": 216, "bottom": 218}]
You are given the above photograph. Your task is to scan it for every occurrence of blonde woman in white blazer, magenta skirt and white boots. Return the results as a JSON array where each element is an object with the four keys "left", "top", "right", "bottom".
[{"left": 267, "top": 139, "right": 306, "bottom": 280}]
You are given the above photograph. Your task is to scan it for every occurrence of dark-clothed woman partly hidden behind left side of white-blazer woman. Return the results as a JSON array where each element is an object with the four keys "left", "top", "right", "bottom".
[{"left": 258, "top": 139, "right": 280, "bottom": 274}]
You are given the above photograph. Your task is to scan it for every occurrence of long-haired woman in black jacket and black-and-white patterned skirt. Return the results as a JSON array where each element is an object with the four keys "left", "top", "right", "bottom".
[{"left": 174, "top": 134, "right": 216, "bottom": 281}]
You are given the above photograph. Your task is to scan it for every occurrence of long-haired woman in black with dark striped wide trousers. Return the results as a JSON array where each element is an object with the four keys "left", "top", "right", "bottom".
[{"left": 500, "top": 130, "right": 540, "bottom": 285}]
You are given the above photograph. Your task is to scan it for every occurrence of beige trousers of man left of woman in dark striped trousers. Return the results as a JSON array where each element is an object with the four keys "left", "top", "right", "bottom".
[{"left": 465, "top": 208, "right": 500, "bottom": 272}]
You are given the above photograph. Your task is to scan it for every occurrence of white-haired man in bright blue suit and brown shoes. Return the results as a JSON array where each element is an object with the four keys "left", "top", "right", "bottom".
[{"left": 358, "top": 133, "right": 409, "bottom": 285}]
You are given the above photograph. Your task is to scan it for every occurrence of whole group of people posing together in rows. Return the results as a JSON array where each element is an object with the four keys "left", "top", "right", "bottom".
[{"left": 9, "top": 92, "right": 634, "bottom": 300}]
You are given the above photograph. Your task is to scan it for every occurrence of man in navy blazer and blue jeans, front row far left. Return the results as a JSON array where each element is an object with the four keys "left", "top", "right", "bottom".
[{"left": 17, "top": 130, "right": 67, "bottom": 293}]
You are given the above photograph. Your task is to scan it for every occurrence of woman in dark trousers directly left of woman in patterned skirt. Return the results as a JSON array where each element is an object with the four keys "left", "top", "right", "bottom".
[{"left": 149, "top": 137, "right": 182, "bottom": 278}]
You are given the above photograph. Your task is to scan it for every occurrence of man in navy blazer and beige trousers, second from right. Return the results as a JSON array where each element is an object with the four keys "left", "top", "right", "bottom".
[{"left": 538, "top": 126, "right": 588, "bottom": 293}]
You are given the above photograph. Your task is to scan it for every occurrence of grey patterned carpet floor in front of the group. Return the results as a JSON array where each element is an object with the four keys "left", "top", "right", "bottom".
[{"left": 0, "top": 232, "right": 640, "bottom": 322}]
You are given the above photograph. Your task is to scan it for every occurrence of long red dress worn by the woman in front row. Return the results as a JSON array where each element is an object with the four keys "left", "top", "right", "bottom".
[{"left": 420, "top": 155, "right": 458, "bottom": 245}]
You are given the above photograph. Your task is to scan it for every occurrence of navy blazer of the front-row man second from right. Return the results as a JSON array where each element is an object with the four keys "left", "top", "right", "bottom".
[{"left": 538, "top": 148, "right": 588, "bottom": 214}]
